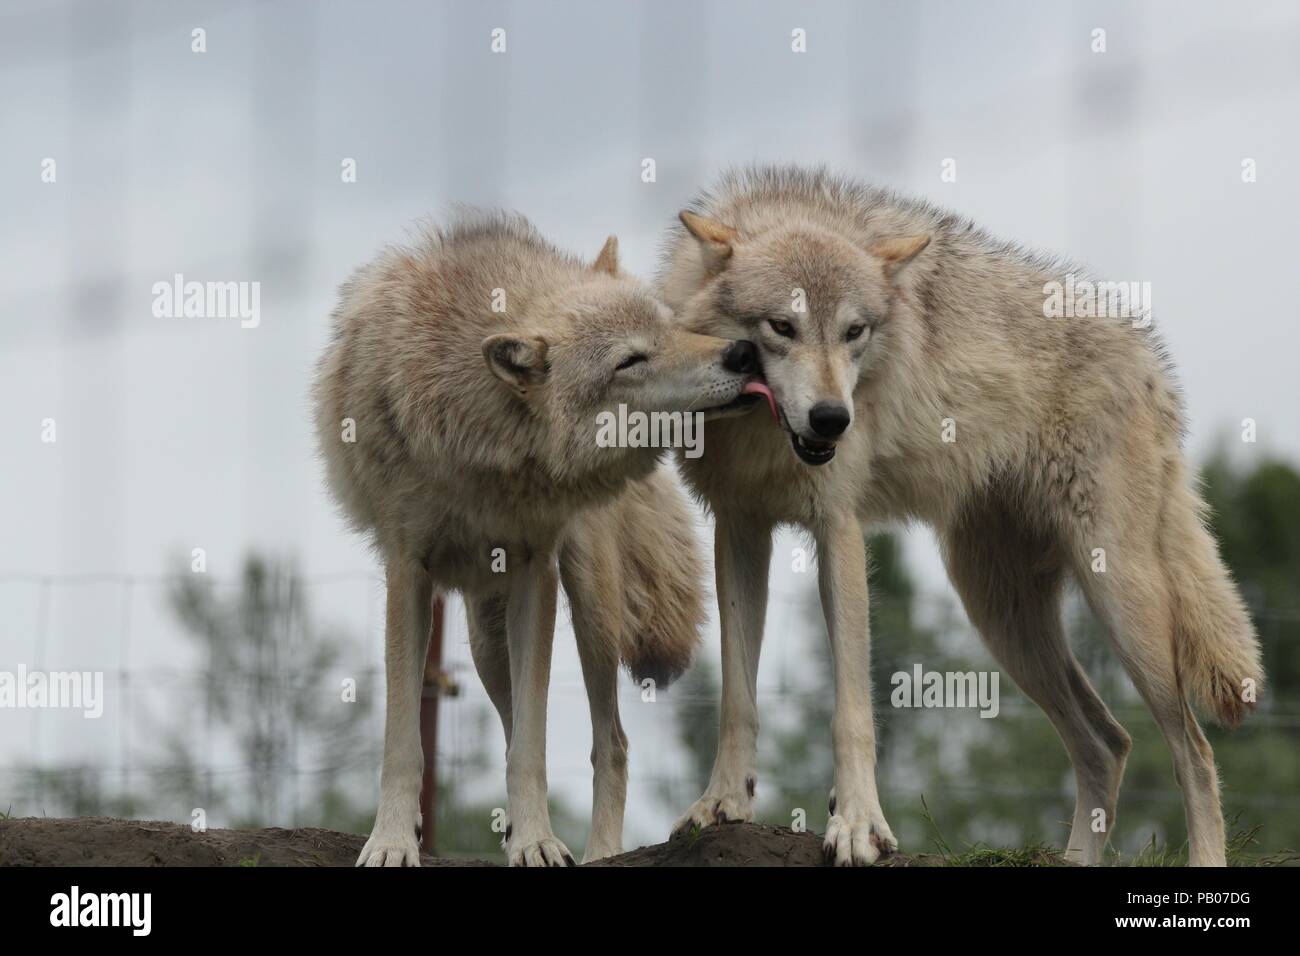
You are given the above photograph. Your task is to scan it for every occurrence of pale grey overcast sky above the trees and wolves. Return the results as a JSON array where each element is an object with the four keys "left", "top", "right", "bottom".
[{"left": 0, "top": 0, "right": 1300, "bottom": 843}]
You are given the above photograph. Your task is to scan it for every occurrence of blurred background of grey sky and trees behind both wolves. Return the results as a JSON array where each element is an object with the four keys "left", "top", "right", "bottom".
[{"left": 0, "top": 0, "right": 1300, "bottom": 858}]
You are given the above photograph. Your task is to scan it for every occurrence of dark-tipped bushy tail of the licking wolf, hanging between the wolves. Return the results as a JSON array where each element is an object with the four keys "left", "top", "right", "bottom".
[{"left": 560, "top": 468, "right": 705, "bottom": 688}]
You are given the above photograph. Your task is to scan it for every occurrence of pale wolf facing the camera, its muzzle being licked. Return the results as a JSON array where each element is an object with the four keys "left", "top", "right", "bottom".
[{"left": 658, "top": 166, "right": 1264, "bottom": 865}]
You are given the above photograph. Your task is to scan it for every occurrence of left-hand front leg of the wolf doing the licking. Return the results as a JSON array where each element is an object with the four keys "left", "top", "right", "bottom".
[{"left": 356, "top": 555, "right": 433, "bottom": 866}]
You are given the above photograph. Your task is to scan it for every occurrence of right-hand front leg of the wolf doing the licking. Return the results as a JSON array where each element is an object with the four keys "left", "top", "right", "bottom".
[{"left": 506, "top": 554, "right": 573, "bottom": 866}]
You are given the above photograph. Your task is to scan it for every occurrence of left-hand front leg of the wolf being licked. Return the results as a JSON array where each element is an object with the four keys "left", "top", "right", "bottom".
[{"left": 672, "top": 511, "right": 772, "bottom": 834}]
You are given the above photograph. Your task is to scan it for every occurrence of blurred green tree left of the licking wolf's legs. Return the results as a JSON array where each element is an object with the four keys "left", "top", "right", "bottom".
[{"left": 164, "top": 555, "right": 374, "bottom": 830}]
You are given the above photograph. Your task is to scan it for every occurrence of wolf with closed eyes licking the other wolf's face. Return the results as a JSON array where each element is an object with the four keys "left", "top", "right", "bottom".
[{"left": 313, "top": 212, "right": 755, "bottom": 866}]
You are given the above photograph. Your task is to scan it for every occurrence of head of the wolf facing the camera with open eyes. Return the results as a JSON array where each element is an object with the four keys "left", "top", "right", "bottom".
[{"left": 680, "top": 211, "right": 930, "bottom": 464}]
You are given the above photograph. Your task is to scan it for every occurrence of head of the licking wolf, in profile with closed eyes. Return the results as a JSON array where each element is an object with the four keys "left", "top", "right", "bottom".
[{"left": 482, "top": 237, "right": 762, "bottom": 477}]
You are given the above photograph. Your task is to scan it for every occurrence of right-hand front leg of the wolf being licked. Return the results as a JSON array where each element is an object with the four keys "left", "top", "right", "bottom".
[{"left": 815, "top": 514, "right": 898, "bottom": 866}]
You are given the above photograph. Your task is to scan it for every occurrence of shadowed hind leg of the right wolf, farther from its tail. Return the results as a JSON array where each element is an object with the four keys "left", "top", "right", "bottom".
[{"left": 943, "top": 506, "right": 1132, "bottom": 865}]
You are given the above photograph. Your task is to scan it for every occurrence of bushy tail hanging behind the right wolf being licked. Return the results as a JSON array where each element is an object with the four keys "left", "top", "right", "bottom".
[{"left": 1161, "top": 466, "right": 1264, "bottom": 727}]
